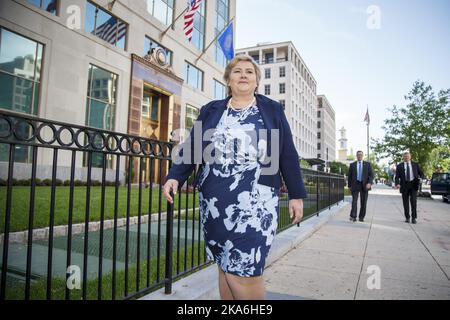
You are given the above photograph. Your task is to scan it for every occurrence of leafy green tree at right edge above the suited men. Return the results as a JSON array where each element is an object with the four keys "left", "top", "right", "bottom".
[{"left": 372, "top": 81, "right": 450, "bottom": 178}]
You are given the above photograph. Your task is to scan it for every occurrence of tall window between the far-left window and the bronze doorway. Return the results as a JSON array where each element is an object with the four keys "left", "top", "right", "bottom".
[{"left": 84, "top": 64, "right": 118, "bottom": 168}]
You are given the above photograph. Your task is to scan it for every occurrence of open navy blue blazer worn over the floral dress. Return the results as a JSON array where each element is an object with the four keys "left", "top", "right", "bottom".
[{"left": 166, "top": 94, "right": 307, "bottom": 199}]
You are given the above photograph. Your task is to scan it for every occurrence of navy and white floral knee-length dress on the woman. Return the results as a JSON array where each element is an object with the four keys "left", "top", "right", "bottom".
[{"left": 199, "top": 105, "right": 279, "bottom": 277}]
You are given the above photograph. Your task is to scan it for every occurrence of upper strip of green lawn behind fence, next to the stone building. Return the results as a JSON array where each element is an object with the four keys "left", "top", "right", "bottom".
[{"left": 0, "top": 186, "right": 198, "bottom": 233}]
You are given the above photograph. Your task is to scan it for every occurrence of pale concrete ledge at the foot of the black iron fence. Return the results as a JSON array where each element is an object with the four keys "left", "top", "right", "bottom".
[{"left": 139, "top": 201, "right": 349, "bottom": 300}]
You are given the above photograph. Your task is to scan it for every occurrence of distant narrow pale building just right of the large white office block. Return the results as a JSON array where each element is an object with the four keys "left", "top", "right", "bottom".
[{"left": 317, "top": 95, "right": 336, "bottom": 163}]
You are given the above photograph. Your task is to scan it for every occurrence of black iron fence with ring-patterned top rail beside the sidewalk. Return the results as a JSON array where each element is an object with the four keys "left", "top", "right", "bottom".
[{"left": 0, "top": 110, "right": 344, "bottom": 300}]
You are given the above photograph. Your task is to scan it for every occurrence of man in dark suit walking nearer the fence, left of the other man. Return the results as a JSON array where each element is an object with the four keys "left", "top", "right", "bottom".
[{"left": 348, "top": 151, "right": 373, "bottom": 222}]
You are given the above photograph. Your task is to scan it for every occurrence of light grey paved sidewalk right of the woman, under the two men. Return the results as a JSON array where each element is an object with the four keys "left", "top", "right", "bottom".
[{"left": 265, "top": 186, "right": 450, "bottom": 300}]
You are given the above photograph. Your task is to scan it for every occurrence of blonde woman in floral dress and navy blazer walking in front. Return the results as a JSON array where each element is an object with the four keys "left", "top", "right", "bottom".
[{"left": 164, "top": 55, "right": 306, "bottom": 299}]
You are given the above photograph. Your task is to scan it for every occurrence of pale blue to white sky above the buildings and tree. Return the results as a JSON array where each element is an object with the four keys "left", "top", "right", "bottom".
[{"left": 236, "top": 0, "right": 450, "bottom": 165}]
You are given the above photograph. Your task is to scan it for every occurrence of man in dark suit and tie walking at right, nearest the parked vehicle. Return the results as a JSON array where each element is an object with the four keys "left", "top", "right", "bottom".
[{"left": 395, "top": 152, "right": 424, "bottom": 224}]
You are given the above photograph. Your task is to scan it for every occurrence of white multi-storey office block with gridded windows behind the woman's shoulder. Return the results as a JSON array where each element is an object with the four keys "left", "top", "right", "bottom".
[{"left": 236, "top": 41, "right": 317, "bottom": 158}]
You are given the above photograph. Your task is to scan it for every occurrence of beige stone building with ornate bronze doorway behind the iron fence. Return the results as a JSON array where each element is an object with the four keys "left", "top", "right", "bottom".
[{"left": 0, "top": 0, "right": 236, "bottom": 184}]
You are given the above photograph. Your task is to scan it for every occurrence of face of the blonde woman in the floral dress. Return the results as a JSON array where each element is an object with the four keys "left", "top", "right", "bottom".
[{"left": 228, "top": 61, "right": 258, "bottom": 95}]
